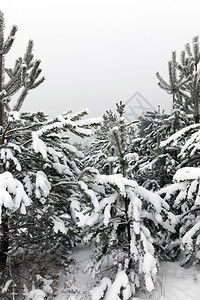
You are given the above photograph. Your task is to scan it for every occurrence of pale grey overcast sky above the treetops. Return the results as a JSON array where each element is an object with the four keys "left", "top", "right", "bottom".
[{"left": 0, "top": 0, "right": 200, "bottom": 117}]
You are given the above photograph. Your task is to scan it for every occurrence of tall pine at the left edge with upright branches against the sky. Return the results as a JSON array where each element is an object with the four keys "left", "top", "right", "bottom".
[{"left": 0, "top": 12, "right": 44, "bottom": 274}]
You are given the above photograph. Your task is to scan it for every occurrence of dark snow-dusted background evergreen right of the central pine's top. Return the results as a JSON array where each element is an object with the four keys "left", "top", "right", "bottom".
[{"left": 133, "top": 109, "right": 192, "bottom": 190}]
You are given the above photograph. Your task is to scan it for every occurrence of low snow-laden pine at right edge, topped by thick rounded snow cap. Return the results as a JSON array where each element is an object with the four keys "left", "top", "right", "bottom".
[{"left": 159, "top": 167, "right": 200, "bottom": 266}]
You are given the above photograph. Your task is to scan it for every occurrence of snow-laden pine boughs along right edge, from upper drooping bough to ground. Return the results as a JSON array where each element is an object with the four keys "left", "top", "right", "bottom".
[{"left": 158, "top": 123, "right": 200, "bottom": 265}]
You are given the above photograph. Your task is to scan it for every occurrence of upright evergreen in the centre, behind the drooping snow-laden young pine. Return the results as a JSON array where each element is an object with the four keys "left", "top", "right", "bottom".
[{"left": 83, "top": 102, "right": 138, "bottom": 178}]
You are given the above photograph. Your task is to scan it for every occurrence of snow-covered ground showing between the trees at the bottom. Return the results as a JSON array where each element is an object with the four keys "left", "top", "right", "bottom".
[{"left": 53, "top": 246, "right": 200, "bottom": 300}]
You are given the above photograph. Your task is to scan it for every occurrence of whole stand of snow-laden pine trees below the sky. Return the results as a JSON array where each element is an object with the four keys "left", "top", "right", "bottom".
[{"left": 0, "top": 12, "right": 200, "bottom": 300}]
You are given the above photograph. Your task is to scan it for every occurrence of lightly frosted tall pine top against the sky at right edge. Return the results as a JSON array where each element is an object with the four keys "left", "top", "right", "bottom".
[{"left": 156, "top": 36, "right": 200, "bottom": 123}]
